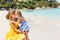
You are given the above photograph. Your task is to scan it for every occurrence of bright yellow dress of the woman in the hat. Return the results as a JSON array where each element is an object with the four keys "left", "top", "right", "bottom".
[{"left": 6, "top": 22, "right": 26, "bottom": 40}]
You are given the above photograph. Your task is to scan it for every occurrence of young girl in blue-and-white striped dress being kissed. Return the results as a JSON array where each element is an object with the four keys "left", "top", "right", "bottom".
[{"left": 15, "top": 11, "right": 29, "bottom": 40}]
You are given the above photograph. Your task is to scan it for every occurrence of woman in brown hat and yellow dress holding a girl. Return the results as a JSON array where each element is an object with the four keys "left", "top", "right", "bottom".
[{"left": 6, "top": 10, "right": 26, "bottom": 40}]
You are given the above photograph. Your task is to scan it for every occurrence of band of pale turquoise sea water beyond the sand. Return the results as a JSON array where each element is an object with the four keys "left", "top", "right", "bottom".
[{"left": 22, "top": 8, "right": 60, "bottom": 18}]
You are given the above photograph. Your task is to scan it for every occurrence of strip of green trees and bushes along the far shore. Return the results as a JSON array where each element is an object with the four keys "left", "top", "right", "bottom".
[{"left": 0, "top": 1, "right": 58, "bottom": 10}]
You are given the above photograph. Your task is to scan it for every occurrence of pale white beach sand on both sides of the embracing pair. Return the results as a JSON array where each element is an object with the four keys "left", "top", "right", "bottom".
[{"left": 0, "top": 11, "right": 60, "bottom": 40}]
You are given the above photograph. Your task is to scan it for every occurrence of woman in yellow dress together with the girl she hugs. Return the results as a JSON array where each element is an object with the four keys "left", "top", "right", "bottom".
[{"left": 6, "top": 10, "right": 29, "bottom": 40}]
